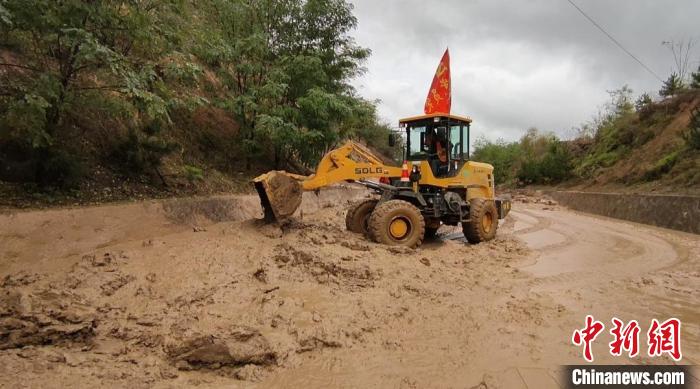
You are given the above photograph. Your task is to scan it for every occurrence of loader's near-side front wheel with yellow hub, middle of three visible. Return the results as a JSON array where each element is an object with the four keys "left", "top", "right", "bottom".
[{"left": 368, "top": 200, "right": 425, "bottom": 247}]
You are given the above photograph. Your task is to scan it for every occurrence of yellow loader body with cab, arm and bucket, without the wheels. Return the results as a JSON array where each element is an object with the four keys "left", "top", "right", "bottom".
[{"left": 254, "top": 114, "right": 510, "bottom": 224}]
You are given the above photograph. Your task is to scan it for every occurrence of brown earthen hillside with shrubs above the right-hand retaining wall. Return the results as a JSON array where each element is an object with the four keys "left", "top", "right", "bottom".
[{"left": 569, "top": 91, "right": 700, "bottom": 193}]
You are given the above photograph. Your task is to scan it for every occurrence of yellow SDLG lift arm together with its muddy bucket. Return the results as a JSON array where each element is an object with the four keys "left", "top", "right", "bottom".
[{"left": 253, "top": 141, "right": 401, "bottom": 222}]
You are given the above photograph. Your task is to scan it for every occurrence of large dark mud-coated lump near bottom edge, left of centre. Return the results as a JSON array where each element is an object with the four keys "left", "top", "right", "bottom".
[{"left": 167, "top": 327, "right": 277, "bottom": 368}]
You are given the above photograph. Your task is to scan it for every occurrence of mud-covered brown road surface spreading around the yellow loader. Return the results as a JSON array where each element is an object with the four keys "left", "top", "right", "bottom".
[{"left": 0, "top": 190, "right": 700, "bottom": 388}]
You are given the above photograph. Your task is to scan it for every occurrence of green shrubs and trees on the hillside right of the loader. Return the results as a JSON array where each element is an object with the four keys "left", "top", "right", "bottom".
[{"left": 473, "top": 83, "right": 700, "bottom": 186}]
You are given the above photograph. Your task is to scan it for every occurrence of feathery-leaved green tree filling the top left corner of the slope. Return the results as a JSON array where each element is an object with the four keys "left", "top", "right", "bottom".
[{"left": 0, "top": 0, "right": 197, "bottom": 183}]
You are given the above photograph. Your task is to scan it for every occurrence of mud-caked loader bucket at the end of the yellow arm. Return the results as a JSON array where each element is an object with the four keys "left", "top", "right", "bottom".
[{"left": 253, "top": 170, "right": 302, "bottom": 223}]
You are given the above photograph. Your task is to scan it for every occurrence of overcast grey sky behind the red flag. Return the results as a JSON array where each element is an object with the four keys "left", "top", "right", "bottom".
[{"left": 351, "top": 0, "right": 700, "bottom": 140}]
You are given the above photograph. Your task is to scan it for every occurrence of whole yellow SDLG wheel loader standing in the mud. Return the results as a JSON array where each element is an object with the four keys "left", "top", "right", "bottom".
[{"left": 254, "top": 114, "right": 511, "bottom": 247}]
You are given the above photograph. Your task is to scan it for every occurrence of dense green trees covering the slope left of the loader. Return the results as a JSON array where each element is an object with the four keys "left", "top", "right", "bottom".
[{"left": 0, "top": 0, "right": 393, "bottom": 192}]
